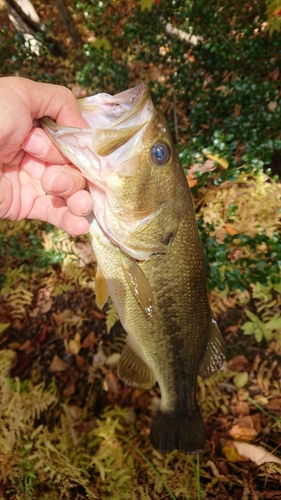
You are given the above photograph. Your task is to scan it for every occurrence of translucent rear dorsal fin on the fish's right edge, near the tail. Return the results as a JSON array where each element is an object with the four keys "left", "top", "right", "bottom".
[{"left": 199, "top": 317, "right": 224, "bottom": 378}]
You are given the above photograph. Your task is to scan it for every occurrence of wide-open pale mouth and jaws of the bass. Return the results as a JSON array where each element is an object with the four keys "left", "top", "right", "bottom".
[{"left": 40, "top": 83, "right": 154, "bottom": 181}]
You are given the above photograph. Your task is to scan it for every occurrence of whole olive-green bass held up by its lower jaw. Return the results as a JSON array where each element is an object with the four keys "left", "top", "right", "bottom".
[{"left": 41, "top": 83, "right": 224, "bottom": 454}]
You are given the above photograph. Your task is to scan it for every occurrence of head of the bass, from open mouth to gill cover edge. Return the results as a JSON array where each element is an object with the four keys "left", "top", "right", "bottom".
[{"left": 42, "top": 84, "right": 183, "bottom": 260}]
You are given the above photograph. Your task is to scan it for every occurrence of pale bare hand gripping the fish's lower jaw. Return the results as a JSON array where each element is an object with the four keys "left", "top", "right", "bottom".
[{"left": 0, "top": 77, "right": 93, "bottom": 235}]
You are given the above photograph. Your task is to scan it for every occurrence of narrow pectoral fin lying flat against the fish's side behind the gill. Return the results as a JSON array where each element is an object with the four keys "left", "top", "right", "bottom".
[{"left": 122, "top": 259, "right": 155, "bottom": 322}]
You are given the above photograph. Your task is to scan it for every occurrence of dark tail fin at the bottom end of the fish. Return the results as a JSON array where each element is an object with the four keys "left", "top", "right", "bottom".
[{"left": 150, "top": 409, "right": 205, "bottom": 455}]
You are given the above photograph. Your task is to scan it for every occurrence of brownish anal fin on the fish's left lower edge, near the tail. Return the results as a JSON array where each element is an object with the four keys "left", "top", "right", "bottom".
[{"left": 117, "top": 341, "right": 156, "bottom": 389}]
